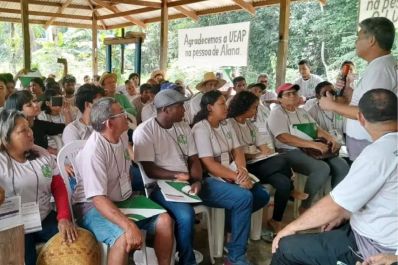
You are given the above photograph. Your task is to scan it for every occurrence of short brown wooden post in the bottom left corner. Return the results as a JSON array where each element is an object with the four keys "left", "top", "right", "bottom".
[{"left": 0, "top": 225, "right": 25, "bottom": 265}]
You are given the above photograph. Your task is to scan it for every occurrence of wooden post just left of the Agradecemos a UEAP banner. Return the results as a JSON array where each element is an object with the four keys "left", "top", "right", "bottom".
[{"left": 159, "top": 0, "right": 169, "bottom": 73}]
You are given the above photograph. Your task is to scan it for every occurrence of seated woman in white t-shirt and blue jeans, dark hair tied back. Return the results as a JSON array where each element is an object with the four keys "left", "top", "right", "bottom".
[{"left": 192, "top": 90, "right": 269, "bottom": 264}]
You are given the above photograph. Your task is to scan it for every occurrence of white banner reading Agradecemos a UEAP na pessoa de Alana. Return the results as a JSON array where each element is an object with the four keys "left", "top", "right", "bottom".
[{"left": 178, "top": 22, "right": 250, "bottom": 67}]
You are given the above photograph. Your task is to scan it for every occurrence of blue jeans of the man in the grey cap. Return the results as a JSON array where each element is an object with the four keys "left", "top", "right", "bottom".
[{"left": 151, "top": 188, "right": 196, "bottom": 265}]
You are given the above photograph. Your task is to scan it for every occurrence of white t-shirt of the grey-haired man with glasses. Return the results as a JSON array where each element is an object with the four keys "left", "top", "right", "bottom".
[{"left": 73, "top": 131, "right": 132, "bottom": 202}]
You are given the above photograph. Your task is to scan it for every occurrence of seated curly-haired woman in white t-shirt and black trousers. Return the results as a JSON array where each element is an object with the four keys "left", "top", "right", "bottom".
[{"left": 228, "top": 91, "right": 306, "bottom": 232}]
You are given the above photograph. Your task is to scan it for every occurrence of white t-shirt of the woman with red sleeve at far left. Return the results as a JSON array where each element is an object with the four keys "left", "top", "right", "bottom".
[{"left": 0, "top": 145, "right": 59, "bottom": 220}]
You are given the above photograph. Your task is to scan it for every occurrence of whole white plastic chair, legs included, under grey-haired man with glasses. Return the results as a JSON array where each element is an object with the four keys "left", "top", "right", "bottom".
[{"left": 57, "top": 140, "right": 148, "bottom": 265}]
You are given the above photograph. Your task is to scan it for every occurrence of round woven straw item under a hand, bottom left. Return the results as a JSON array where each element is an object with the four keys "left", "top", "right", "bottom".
[{"left": 36, "top": 228, "right": 101, "bottom": 265}]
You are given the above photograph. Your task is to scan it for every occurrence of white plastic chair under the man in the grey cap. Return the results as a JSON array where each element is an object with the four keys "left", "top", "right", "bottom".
[{"left": 137, "top": 163, "right": 215, "bottom": 264}]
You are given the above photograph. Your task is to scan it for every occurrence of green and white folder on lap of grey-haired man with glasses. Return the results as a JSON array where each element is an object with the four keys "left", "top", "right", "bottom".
[{"left": 115, "top": 195, "right": 166, "bottom": 222}]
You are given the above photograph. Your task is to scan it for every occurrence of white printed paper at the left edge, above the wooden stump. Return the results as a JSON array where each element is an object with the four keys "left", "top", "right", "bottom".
[{"left": 0, "top": 196, "right": 23, "bottom": 231}]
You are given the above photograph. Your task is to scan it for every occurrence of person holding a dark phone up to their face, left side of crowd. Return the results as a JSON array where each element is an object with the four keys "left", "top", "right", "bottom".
[{"left": 37, "top": 89, "right": 73, "bottom": 154}]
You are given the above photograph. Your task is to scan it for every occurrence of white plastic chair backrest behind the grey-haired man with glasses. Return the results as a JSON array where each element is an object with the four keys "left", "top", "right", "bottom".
[{"left": 57, "top": 140, "right": 86, "bottom": 220}]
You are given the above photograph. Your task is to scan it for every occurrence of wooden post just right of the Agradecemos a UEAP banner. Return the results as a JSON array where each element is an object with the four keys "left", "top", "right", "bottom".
[{"left": 276, "top": 0, "right": 290, "bottom": 87}]
